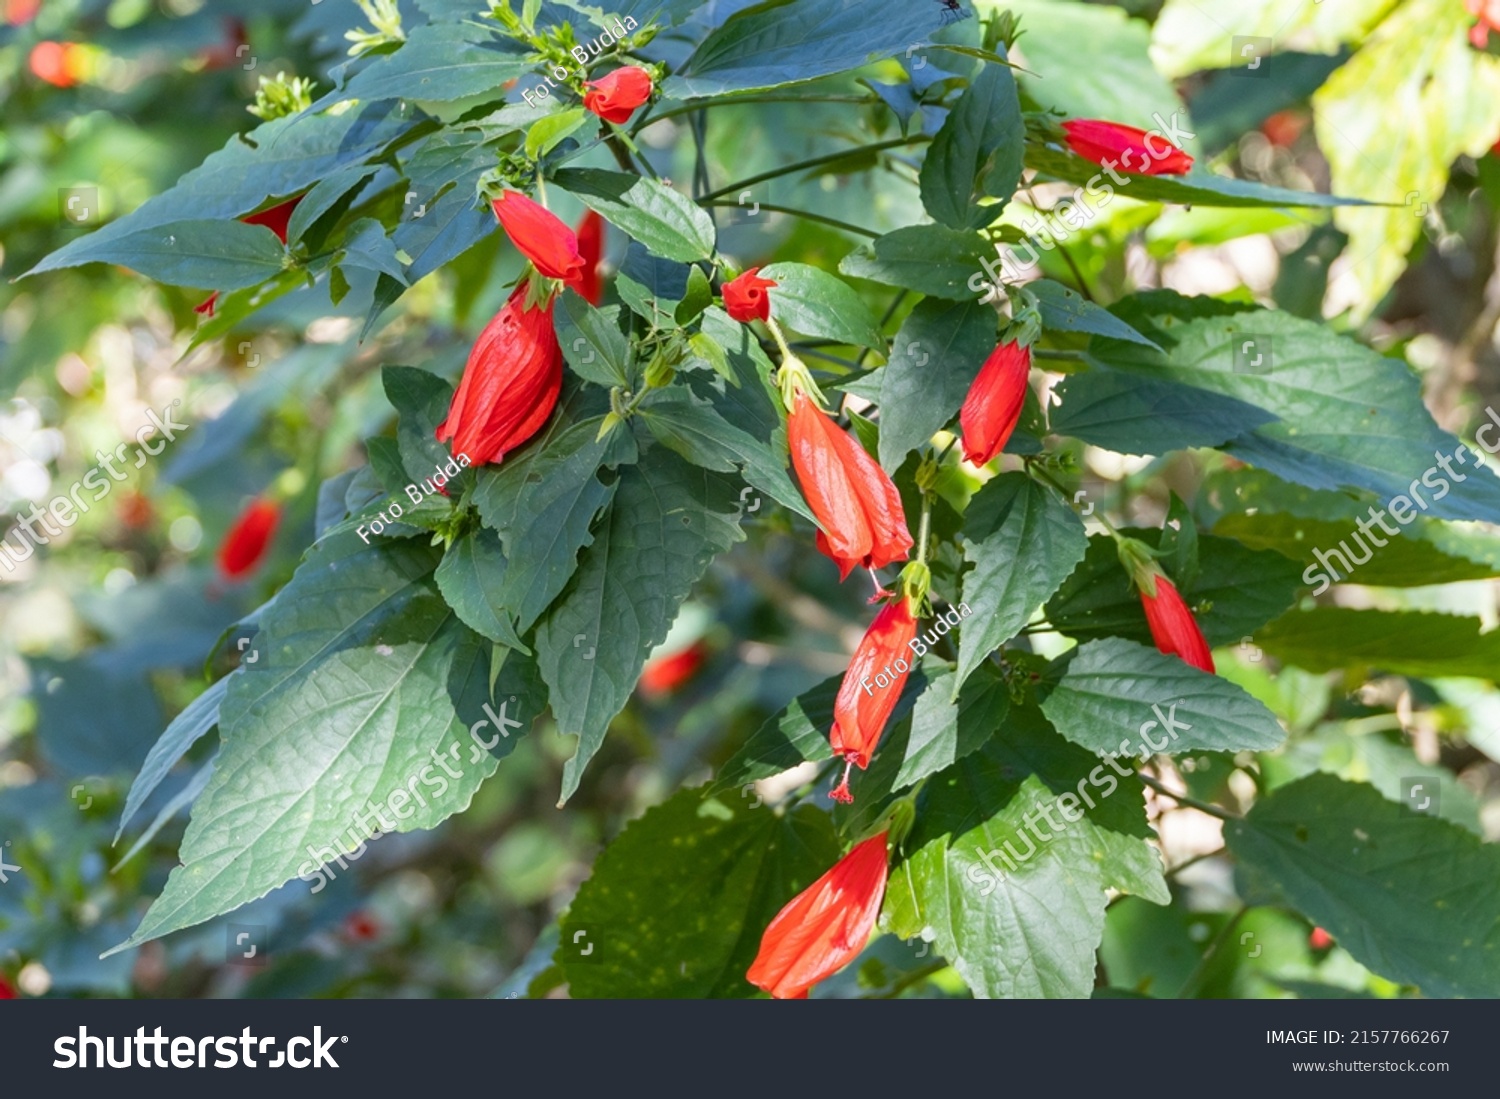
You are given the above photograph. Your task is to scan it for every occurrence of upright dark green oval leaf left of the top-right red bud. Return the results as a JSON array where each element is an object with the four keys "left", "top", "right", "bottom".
[{"left": 920, "top": 52, "right": 1026, "bottom": 227}]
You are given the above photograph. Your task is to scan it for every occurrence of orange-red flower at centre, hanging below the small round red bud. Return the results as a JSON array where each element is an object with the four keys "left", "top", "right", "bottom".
[{"left": 786, "top": 391, "right": 912, "bottom": 579}]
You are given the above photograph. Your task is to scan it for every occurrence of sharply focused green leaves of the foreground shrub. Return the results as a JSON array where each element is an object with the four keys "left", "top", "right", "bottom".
[{"left": 8, "top": 0, "right": 1500, "bottom": 996}]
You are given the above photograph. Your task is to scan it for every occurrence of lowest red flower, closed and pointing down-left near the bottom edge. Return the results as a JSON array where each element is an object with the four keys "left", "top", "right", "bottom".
[{"left": 746, "top": 832, "right": 887, "bottom": 1000}]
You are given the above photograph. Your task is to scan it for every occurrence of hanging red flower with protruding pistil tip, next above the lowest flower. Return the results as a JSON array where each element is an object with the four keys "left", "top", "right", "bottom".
[{"left": 828, "top": 597, "right": 917, "bottom": 804}]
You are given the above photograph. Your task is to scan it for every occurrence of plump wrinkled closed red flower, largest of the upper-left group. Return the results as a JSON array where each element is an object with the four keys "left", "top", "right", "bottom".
[{"left": 438, "top": 283, "right": 572, "bottom": 465}]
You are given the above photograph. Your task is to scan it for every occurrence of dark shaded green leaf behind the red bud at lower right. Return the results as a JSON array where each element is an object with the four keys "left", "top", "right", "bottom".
[{"left": 1047, "top": 528, "right": 1299, "bottom": 645}]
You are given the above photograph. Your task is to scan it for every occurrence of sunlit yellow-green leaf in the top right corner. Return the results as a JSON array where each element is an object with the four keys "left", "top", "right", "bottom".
[{"left": 1314, "top": 0, "right": 1500, "bottom": 319}]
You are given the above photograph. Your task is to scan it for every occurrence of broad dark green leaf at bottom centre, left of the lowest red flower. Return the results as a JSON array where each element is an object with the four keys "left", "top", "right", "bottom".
[{"left": 557, "top": 790, "right": 840, "bottom": 999}]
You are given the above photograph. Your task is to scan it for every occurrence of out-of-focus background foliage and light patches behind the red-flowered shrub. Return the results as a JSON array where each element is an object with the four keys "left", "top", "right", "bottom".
[{"left": 0, "top": 0, "right": 1500, "bottom": 997}]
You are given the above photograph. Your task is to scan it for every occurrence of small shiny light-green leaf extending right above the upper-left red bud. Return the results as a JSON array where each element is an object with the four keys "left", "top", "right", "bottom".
[{"left": 554, "top": 168, "right": 714, "bottom": 262}]
